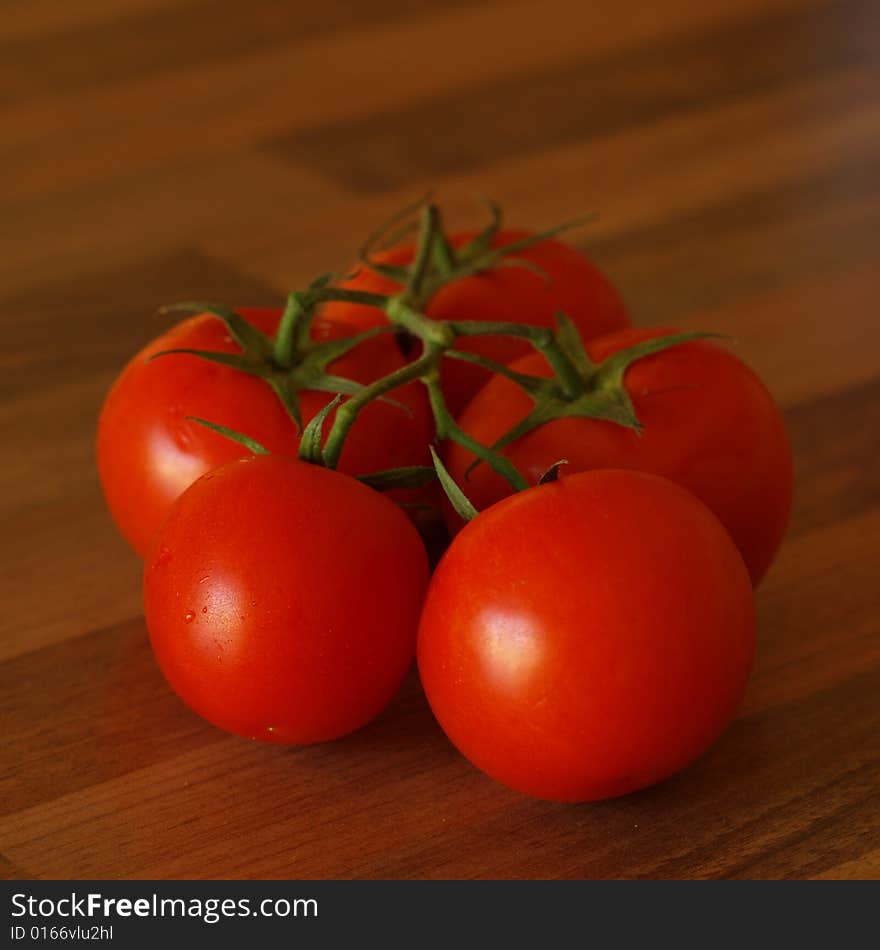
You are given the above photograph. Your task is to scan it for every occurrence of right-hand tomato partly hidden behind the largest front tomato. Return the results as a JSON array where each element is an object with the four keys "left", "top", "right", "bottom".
[{"left": 445, "top": 329, "right": 793, "bottom": 584}]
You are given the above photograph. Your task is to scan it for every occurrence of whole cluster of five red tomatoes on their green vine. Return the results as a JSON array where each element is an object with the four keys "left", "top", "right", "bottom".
[{"left": 98, "top": 208, "right": 792, "bottom": 801}]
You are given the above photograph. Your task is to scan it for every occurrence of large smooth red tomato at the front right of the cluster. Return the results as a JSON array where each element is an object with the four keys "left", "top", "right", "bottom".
[{"left": 418, "top": 470, "right": 755, "bottom": 802}]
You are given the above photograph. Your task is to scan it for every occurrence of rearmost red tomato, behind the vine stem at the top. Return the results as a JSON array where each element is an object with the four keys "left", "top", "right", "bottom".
[{"left": 325, "top": 231, "right": 629, "bottom": 414}]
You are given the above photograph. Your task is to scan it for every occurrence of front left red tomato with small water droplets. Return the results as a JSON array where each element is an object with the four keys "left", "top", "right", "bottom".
[{"left": 144, "top": 456, "right": 428, "bottom": 743}]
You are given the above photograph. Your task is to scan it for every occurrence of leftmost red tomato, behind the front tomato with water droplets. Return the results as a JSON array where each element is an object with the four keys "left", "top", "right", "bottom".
[{"left": 97, "top": 308, "right": 434, "bottom": 556}]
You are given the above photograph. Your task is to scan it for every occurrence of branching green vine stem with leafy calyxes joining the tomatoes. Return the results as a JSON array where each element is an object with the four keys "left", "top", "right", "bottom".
[{"left": 168, "top": 202, "right": 714, "bottom": 517}]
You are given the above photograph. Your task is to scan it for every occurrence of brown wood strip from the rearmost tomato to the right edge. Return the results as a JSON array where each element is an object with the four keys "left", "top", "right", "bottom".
[{"left": 584, "top": 156, "right": 880, "bottom": 324}]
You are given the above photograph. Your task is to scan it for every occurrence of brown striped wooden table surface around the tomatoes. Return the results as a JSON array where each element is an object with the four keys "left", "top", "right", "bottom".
[{"left": 0, "top": 0, "right": 880, "bottom": 878}]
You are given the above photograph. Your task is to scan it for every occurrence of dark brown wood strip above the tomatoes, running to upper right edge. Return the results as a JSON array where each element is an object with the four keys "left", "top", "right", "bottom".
[{"left": 267, "top": 0, "right": 880, "bottom": 192}]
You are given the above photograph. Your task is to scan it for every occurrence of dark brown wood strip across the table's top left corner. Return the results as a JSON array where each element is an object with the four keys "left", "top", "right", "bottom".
[{"left": 0, "top": 0, "right": 482, "bottom": 104}]
